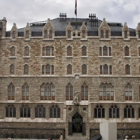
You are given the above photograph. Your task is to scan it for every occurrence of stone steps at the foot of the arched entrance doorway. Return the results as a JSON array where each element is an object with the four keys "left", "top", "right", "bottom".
[{"left": 67, "top": 133, "right": 86, "bottom": 140}]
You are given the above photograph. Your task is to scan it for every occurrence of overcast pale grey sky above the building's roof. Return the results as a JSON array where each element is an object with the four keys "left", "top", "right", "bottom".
[{"left": 0, "top": 0, "right": 140, "bottom": 30}]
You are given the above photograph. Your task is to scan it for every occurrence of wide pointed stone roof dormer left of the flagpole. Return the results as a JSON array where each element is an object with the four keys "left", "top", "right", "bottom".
[{"left": 42, "top": 19, "right": 55, "bottom": 38}]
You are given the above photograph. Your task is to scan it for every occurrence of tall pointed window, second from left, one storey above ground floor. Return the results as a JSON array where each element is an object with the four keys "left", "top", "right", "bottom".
[{"left": 22, "top": 83, "right": 29, "bottom": 100}]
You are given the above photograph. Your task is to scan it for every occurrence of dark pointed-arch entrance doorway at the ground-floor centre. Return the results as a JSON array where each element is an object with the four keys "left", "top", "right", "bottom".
[{"left": 72, "top": 113, "right": 83, "bottom": 133}]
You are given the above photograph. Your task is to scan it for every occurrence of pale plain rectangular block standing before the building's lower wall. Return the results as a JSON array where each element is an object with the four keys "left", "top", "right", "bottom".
[{"left": 100, "top": 123, "right": 117, "bottom": 140}]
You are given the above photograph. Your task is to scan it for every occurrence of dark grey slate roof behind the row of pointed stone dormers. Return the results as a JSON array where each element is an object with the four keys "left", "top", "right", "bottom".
[{"left": 6, "top": 18, "right": 136, "bottom": 37}]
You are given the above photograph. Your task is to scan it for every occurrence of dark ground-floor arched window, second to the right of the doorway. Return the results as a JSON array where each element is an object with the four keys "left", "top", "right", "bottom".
[{"left": 109, "top": 105, "right": 120, "bottom": 118}]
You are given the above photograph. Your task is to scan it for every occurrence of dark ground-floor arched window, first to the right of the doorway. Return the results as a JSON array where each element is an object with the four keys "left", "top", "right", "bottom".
[{"left": 94, "top": 105, "right": 105, "bottom": 118}]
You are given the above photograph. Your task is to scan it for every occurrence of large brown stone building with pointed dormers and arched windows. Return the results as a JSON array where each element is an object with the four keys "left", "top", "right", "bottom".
[{"left": 0, "top": 14, "right": 140, "bottom": 139}]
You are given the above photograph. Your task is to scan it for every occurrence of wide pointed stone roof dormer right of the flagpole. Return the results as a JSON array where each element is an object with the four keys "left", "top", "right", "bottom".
[{"left": 98, "top": 18, "right": 111, "bottom": 38}]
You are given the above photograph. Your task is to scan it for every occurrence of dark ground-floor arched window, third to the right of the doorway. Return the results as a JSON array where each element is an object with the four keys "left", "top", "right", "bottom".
[{"left": 124, "top": 105, "right": 135, "bottom": 118}]
